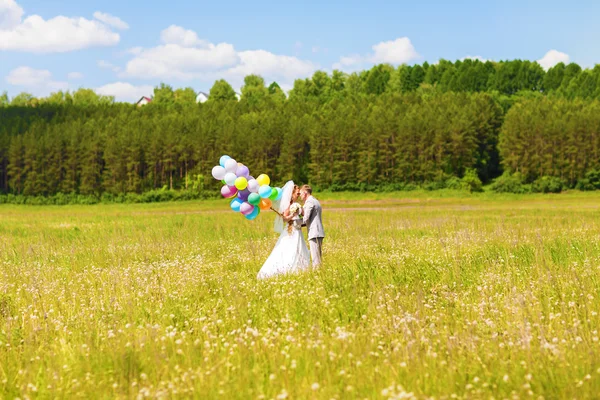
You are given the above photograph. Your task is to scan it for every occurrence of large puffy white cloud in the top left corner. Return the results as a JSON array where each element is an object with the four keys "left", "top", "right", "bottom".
[{"left": 0, "top": 0, "right": 122, "bottom": 53}]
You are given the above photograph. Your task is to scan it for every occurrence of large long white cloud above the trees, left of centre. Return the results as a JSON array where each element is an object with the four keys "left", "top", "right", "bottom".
[{"left": 120, "top": 25, "right": 316, "bottom": 86}]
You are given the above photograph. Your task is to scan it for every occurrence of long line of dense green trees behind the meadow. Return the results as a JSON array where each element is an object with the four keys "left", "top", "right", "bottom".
[{"left": 0, "top": 60, "right": 600, "bottom": 197}]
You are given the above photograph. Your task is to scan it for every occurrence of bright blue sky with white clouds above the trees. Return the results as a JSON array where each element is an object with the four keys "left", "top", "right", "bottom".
[{"left": 0, "top": 0, "right": 600, "bottom": 102}]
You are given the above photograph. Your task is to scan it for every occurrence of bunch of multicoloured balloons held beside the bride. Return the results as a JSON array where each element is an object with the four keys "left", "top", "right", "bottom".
[{"left": 212, "top": 156, "right": 283, "bottom": 220}]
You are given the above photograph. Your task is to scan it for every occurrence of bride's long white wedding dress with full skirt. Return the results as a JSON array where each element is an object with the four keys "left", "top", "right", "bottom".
[{"left": 258, "top": 218, "right": 310, "bottom": 279}]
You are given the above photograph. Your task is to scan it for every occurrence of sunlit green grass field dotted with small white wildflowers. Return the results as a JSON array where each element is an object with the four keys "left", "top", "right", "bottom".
[{"left": 0, "top": 192, "right": 600, "bottom": 399}]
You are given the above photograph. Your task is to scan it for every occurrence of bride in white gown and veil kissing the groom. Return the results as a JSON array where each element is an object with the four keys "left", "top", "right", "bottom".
[{"left": 257, "top": 181, "right": 310, "bottom": 279}]
